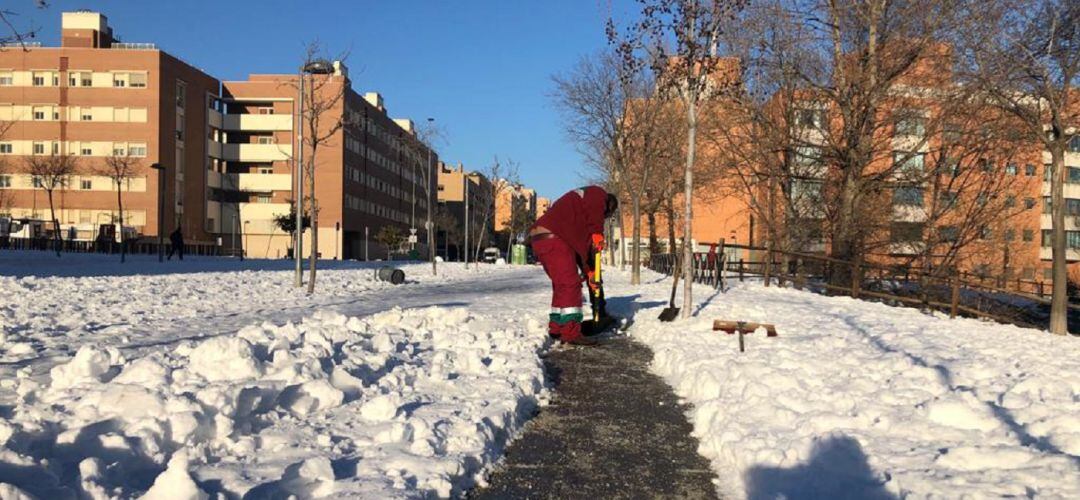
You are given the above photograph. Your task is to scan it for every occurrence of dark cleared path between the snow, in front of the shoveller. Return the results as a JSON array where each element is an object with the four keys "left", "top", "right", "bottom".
[{"left": 470, "top": 338, "right": 716, "bottom": 500}]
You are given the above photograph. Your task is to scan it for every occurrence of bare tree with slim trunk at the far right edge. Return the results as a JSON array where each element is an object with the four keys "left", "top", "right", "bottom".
[{"left": 962, "top": 0, "right": 1080, "bottom": 335}]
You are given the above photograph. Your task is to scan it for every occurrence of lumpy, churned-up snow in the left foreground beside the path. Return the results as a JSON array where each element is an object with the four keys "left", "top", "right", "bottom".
[{"left": 0, "top": 307, "right": 546, "bottom": 499}]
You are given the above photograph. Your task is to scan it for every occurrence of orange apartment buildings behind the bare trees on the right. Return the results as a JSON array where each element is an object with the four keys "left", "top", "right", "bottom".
[{"left": 624, "top": 50, "right": 1080, "bottom": 282}]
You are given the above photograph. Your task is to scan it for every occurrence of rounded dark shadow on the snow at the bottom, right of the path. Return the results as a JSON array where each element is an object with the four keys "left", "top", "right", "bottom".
[{"left": 746, "top": 434, "right": 896, "bottom": 500}]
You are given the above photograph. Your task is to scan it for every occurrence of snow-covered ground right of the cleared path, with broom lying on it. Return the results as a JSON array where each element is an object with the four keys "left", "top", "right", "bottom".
[{"left": 626, "top": 272, "right": 1080, "bottom": 498}]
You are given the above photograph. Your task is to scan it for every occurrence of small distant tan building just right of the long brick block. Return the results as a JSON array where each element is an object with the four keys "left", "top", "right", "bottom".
[{"left": 436, "top": 162, "right": 495, "bottom": 259}]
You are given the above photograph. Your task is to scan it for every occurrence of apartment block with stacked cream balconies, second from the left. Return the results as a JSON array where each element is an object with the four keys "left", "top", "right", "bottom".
[{"left": 217, "top": 75, "right": 438, "bottom": 259}]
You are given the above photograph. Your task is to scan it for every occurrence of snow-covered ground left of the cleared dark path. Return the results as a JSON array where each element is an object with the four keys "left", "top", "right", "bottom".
[{"left": 0, "top": 253, "right": 546, "bottom": 499}]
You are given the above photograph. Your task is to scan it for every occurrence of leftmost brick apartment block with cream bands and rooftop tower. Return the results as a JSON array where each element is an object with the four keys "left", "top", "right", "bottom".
[{"left": 0, "top": 12, "right": 219, "bottom": 243}]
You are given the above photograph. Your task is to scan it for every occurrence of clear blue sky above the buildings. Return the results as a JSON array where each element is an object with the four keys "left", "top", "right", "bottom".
[{"left": 16, "top": 0, "right": 630, "bottom": 197}]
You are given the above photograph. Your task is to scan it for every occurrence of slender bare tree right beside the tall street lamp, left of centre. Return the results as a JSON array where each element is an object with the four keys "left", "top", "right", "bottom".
[{"left": 298, "top": 42, "right": 349, "bottom": 294}]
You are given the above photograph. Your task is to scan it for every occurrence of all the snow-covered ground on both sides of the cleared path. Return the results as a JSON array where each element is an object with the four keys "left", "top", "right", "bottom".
[{"left": 0, "top": 253, "right": 1080, "bottom": 499}]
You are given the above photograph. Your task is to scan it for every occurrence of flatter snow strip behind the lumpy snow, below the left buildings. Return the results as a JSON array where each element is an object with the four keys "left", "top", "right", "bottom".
[{"left": 0, "top": 251, "right": 494, "bottom": 363}]
